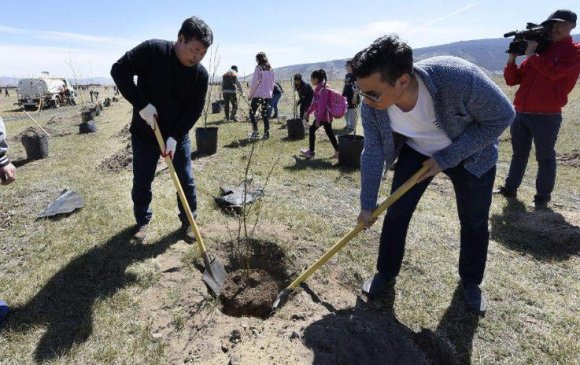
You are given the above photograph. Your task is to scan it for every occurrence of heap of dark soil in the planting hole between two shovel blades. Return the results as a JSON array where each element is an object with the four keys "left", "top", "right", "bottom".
[{"left": 222, "top": 269, "right": 280, "bottom": 318}]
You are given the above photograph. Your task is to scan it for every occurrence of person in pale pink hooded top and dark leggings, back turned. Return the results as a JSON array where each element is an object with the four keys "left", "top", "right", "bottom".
[{"left": 249, "top": 52, "right": 276, "bottom": 139}]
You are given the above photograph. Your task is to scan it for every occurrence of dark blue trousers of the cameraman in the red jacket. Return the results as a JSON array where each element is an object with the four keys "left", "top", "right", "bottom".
[{"left": 505, "top": 113, "right": 562, "bottom": 202}]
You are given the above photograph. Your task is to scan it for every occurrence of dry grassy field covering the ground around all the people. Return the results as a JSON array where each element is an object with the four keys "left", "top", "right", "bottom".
[{"left": 0, "top": 78, "right": 580, "bottom": 364}]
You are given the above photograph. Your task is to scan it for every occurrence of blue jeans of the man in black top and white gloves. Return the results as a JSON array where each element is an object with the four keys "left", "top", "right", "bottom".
[{"left": 131, "top": 135, "right": 197, "bottom": 226}]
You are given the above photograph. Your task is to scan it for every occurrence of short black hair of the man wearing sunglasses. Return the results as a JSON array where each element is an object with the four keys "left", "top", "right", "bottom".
[{"left": 352, "top": 34, "right": 413, "bottom": 86}]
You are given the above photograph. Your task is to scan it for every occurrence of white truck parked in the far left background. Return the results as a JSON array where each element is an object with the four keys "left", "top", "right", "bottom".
[{"left": 16, "top": 77, "right": 74, "bottom": 109}]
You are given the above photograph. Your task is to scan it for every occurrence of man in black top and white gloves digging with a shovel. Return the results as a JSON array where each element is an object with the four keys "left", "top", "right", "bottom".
[{"left": 111, "top": 17, "right": 213, "bottom": 242}]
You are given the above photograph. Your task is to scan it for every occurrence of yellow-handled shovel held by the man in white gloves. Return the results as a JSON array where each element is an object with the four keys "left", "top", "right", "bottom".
[{"left": 154, "top": 123, "right": 226, "bottom": 296}]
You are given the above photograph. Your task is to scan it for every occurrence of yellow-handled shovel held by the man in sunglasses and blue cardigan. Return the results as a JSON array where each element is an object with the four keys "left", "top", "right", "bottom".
[{"left": 272, "top": 166, "right": 429, "bottom": 312}]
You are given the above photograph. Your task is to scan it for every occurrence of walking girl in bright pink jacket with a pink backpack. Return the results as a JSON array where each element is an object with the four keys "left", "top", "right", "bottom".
[{"left": 300, "top": 69, "right": 338, "bottom": 159}]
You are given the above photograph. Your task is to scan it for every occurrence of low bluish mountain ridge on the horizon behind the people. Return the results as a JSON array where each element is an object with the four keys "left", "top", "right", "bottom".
[{"left": 254, "top": 34, "right": 580, "bottom": 80}]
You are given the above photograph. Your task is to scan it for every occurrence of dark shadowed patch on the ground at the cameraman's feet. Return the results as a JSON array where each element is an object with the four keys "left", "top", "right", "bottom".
[{"left": 490, "top": 199, "right": 580, "bottom": 261}]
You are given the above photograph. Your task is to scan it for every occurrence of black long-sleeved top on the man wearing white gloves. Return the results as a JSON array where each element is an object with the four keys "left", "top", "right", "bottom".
[{"left": 111, "top": 40, "right": 208, "bottom": 145}]
